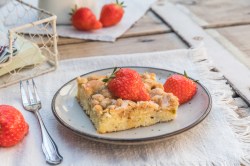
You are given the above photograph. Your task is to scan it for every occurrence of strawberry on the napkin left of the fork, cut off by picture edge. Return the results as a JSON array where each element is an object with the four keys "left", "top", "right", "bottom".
[{"left": 0, "top": 105, "right": 29, "bottom": 147}]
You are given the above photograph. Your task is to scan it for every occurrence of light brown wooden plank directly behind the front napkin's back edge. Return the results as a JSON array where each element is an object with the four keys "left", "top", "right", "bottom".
[{"left": 58, "top": 33, "right": 187, "bottom": 59}]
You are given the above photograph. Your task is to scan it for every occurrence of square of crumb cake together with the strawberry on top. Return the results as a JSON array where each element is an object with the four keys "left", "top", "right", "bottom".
[{"left": 77, "top": 68, "right": 179, "bottom": 133}]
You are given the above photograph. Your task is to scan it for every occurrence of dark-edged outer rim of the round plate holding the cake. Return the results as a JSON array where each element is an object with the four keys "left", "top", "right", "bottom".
[{"left": 51, "top": 66, "right": 212, "bottom": 145}]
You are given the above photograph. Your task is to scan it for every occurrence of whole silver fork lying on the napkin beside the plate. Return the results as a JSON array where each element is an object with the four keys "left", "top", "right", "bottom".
[{"left": 20, "top": 79, "right": 63, "bottom": 164}]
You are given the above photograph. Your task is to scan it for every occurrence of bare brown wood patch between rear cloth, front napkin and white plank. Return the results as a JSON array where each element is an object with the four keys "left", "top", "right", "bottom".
[{"left": 58, "top": 11, "right": 187, "bottom": 59}]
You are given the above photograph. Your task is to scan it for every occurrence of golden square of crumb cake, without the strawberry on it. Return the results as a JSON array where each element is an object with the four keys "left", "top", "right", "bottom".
[{"left": 77, "top": 73, "right": 179, "bottom": 133}]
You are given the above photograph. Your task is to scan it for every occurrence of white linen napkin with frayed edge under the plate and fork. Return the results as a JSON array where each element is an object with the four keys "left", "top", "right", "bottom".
[{"left": 0, "top": 49, "right": 250, "bottom": 166}]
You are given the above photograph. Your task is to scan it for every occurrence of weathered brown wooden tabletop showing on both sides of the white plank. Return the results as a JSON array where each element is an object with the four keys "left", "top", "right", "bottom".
[{"left": 58, "top": 0, "right": 250, "bottom": 117}]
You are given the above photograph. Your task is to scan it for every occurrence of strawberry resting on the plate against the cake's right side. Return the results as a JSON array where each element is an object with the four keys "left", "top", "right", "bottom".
[{"left": 164, "top": 72, "right": 197, "bottom": 104}]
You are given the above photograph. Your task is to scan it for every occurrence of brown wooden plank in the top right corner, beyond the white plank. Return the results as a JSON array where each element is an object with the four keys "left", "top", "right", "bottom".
[{"left": 170, "top": 0, "right": 250, "bottom": 28}]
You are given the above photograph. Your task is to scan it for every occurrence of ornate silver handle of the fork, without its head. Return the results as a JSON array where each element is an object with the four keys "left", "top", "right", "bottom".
[{"left": 35, "top": 111, "right": 63, "bottom": 165}]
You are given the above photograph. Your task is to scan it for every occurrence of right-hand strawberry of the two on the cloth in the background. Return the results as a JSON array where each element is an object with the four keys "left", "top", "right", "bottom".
[{"left": 100, "top": 0, "right": 124, "bottom": 27}]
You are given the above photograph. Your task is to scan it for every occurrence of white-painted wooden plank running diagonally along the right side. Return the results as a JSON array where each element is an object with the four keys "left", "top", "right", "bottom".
[{"left": 152, "top": 1, "right": 250, "bottom": 103}]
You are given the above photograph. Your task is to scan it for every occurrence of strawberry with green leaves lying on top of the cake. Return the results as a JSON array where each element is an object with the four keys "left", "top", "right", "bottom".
[{"left": 106, "top": 68, "right": 150, "bottom": 101}]
